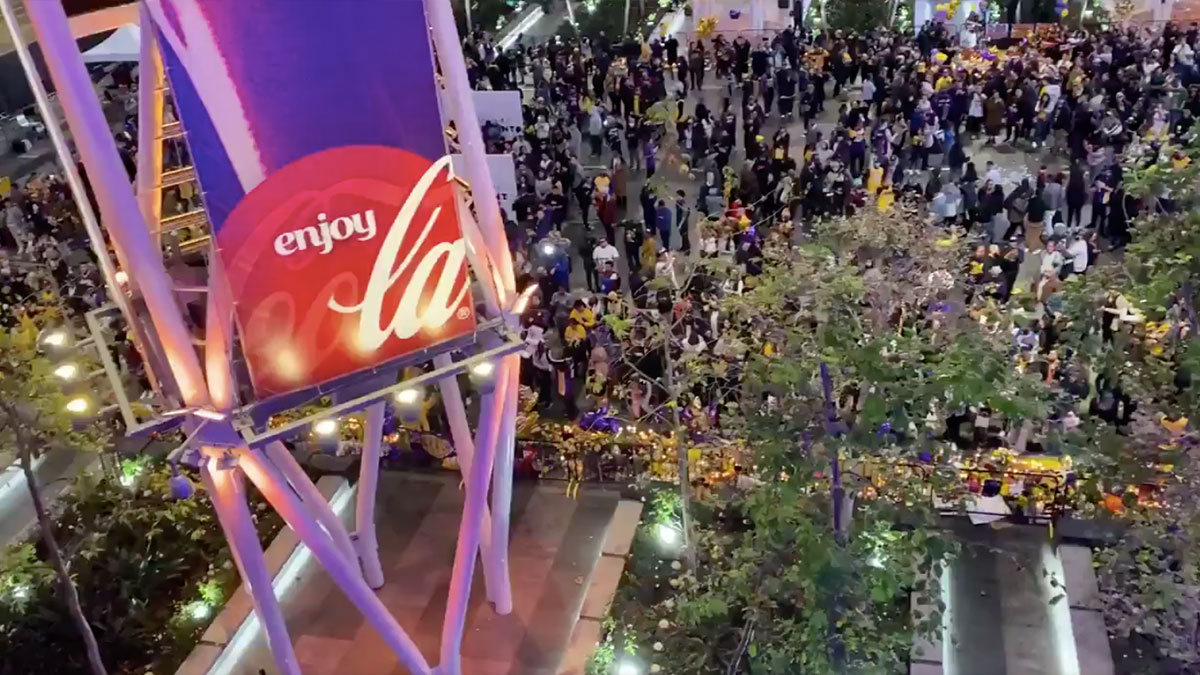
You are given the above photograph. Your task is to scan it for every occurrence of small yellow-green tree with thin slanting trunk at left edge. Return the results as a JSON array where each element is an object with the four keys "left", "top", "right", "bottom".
[{"left": 0, "top": 310, "right": 107, "bottom": 675}]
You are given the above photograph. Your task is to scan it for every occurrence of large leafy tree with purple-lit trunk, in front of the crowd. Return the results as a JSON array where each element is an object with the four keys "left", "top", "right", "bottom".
[{"left": 600, "top": 204, "right": 1046, "bottom": 674}]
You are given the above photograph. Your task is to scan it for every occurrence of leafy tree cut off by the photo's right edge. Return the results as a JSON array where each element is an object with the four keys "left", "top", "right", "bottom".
[{"left": 1060, "top": 138, "right": 1200, "bottom": 670}]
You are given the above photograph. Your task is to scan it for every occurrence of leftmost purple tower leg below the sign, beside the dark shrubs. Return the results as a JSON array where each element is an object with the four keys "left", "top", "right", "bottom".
[{"left": 200, "top": 458, "right": 300, "bottom": 675}]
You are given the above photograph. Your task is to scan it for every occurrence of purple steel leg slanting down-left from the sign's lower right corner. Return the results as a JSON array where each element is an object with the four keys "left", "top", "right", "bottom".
[{"left": 438, "top": 359, "right": 510, "bottom": 675}]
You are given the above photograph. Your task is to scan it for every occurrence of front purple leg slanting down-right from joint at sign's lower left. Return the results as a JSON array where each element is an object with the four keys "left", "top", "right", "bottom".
[{"left": 238, "top": 446, "right": 430, "bottom": 675}]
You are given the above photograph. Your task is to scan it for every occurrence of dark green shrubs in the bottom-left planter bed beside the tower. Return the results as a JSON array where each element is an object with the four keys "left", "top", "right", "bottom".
[{"left": 0, "top": 466, "right": 282, "bottom": 675}]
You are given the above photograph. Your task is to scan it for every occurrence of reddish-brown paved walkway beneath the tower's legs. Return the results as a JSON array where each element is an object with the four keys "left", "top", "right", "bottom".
[{"left": 224, "top": 472, "right": 617, "bottom": 675}]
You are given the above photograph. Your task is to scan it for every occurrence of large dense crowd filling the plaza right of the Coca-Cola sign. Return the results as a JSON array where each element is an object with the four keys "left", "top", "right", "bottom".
[{"left": 464, "top": 14, "right": 1200, "bottom": 449}]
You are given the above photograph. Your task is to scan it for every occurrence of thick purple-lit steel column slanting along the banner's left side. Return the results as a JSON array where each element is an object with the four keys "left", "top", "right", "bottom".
[{"left": 25, "top": 0, "right": 209, "bottom": 405}]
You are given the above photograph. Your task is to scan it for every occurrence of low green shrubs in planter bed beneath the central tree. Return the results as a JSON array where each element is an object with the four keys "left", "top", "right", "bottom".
[{"left": 613, "top": 473, "right": 952, "bottom": 674}]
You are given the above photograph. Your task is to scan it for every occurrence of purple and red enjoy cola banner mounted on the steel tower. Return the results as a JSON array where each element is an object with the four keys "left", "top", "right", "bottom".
[{"left": 146, "top": 0, "right": 475, "bottom": 396}]
